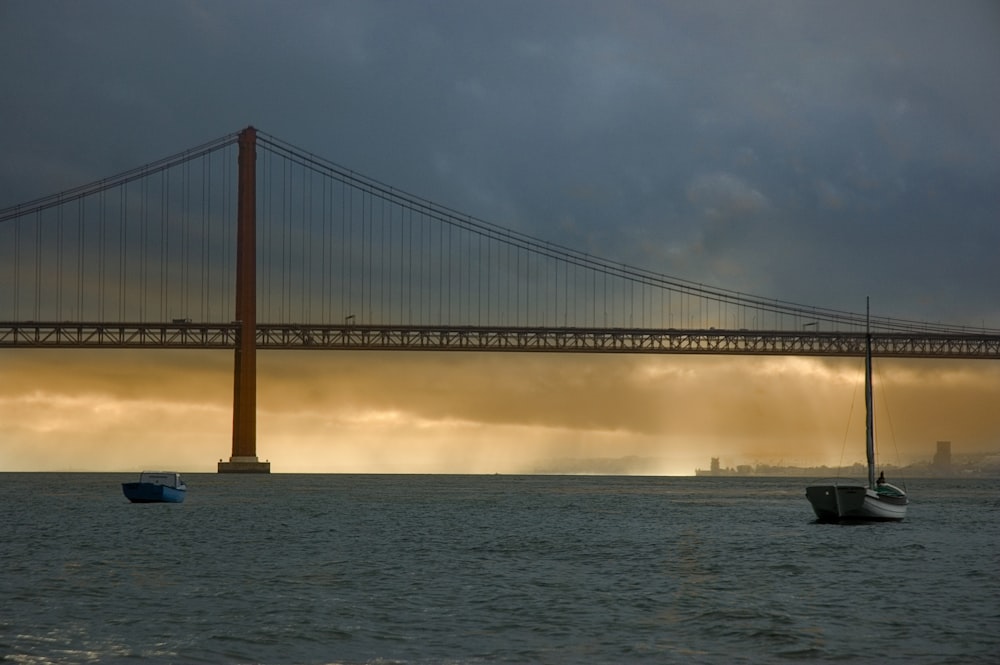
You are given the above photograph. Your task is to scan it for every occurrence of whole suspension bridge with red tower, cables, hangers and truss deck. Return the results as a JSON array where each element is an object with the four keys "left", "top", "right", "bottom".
[{"left": 0, "top": 127, "right": 1000, "bottom": 472}]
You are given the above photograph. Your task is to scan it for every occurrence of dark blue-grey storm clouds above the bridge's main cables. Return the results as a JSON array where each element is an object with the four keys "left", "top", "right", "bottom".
[{"left": 0, "top": 2, "right": 1000, "bottom": 326}]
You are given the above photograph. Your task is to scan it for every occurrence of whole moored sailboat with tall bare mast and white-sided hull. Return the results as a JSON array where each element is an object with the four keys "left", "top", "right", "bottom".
[{"left": 806, "top": 302, "right": 909, "bottom": 522}]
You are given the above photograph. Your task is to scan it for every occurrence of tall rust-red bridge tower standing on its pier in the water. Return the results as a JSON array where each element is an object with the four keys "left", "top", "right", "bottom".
[{"left": 219, "top": 127, "right": 271, "bottom": 473}]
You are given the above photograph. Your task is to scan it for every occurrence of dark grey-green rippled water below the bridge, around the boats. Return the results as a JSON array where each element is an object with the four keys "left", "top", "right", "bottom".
[{"left": 0, "top": 474, "right": 1000, "bottom": 664}]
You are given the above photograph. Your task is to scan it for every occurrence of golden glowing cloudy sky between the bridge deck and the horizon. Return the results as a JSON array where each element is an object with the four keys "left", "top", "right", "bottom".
[{"left": 0, "top": 350, "right": 1000, "bottom": 473}]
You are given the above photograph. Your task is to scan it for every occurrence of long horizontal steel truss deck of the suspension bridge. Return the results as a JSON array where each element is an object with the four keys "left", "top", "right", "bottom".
[{"left": 0, "top": 322, "right": 1000, "bottom": 360}]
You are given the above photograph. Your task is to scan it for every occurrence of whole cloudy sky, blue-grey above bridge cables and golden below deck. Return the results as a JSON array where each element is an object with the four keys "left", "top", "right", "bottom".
[{"left": 0, "top": 0, "right": 1000, "bottom": 475}]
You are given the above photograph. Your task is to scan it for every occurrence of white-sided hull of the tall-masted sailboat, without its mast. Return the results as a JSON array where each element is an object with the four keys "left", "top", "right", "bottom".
[{"left": 806, "top": 485, "right": 909, "bottom": 522}]
